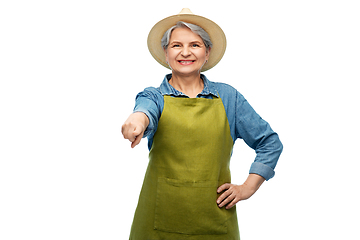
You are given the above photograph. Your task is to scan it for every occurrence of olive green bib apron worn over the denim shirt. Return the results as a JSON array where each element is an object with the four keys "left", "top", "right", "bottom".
[{"left": 130, "top": 96, "right": 240, "bottom": 240}]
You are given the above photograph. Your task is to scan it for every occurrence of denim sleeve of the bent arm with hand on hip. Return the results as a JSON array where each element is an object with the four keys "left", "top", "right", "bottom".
[{"left": 235, "top": 92, "right": 283, "bottom": 181}]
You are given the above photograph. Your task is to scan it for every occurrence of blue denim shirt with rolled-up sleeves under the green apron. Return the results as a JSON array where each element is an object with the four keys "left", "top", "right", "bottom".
[{"left": 134, "top": 74, "right": 283, "bottom": 180}]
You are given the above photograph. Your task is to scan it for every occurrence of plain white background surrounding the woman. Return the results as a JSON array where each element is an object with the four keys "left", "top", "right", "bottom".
[{"left": 0, "top": 0, "right": 360, "bottom": 240}]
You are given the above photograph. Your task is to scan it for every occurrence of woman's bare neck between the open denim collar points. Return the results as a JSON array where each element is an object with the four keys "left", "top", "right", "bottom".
[{"left": 169, "top": 72, "right": 204, "bottom": 98}]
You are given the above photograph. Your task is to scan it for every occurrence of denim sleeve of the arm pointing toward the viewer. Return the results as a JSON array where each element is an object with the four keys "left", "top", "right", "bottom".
[{"left": 133, "top": 87, "right": 164, "bottom": 138}]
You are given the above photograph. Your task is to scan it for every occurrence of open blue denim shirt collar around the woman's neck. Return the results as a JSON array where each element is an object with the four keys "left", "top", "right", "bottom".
[{"left": 160, "top": 73, "right": 219, "bottom": 97}]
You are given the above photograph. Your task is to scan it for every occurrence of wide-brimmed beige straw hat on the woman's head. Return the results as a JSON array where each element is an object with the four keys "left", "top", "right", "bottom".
[{"left": 147, "top": 8, "right": 226, "bottom": 72}]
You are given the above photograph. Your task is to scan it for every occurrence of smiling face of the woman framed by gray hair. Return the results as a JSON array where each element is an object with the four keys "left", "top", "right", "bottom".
[{"left": 165, "top": 28, "right": 210, "bottom": 75}]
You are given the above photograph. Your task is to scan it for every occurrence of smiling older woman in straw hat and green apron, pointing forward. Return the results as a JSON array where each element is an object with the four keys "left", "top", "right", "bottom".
[{"left": 122, "top": 9, "right": 282, "bottom": 240}]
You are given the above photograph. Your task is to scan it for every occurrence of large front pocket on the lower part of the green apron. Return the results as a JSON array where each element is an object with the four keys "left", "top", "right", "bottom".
[{"left": 154, "top": 178, "right": 229, "bottom": 235}]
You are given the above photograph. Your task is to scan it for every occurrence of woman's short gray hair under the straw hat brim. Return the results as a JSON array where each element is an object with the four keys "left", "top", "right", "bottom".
[{"left": 161, "top": 21, "right": 212, "bottom": 50}]
